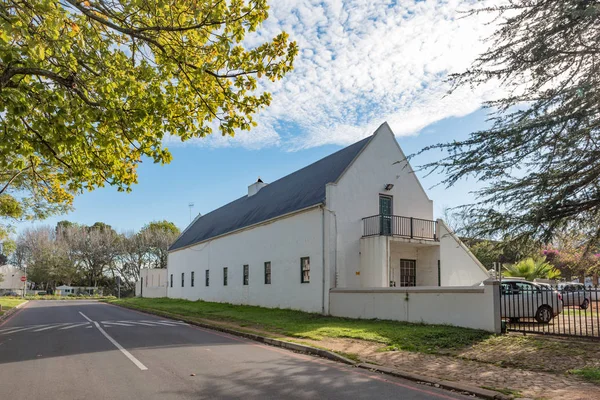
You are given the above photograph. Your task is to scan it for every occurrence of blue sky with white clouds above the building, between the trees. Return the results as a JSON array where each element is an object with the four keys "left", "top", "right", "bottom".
[{"left": 17, "top": 0, "right": 501, "bottom": 231}]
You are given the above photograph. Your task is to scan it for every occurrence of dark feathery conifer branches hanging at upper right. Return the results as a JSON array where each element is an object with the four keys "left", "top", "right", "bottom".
[{"left": 425, "top": 0, "right": 600, "bottom": 250}]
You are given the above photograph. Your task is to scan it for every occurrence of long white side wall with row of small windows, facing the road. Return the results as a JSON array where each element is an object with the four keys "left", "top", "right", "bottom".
[{"left": 167, "top": 207, "right": 324, "bottom": 312}]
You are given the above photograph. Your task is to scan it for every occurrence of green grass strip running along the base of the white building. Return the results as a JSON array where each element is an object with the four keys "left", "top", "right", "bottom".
[{"left": 109, "top": 298, "right": 492, "bottom": 353}]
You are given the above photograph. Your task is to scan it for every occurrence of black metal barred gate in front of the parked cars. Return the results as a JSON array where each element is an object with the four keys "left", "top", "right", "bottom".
[{"left": 500, "top": 279, "right": 600, "bottom": 339}]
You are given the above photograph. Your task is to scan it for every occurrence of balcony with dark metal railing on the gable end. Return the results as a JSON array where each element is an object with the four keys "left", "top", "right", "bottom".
[{"left": 363, "top": 214, "right": 439, "bottom": 242}]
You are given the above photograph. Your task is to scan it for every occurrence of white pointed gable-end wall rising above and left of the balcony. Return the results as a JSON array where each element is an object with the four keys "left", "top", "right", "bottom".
[{"left": 326, "top": 124, "right": 433, "bottom": 287}]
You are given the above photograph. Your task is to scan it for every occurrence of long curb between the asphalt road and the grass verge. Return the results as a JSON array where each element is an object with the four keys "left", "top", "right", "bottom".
[{"left": 106, "top": 303, "right": 513, "bottom": 400}]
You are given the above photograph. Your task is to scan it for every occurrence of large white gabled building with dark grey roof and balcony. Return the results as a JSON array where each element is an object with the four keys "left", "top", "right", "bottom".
[{"left": 167, "top": 123, "right": 488, "bottom": 313}]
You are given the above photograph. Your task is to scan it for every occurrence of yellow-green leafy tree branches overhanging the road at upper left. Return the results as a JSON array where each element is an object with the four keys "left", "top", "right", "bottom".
[{"left": 0, "top": 0, "right": 298, "bottom": 223}]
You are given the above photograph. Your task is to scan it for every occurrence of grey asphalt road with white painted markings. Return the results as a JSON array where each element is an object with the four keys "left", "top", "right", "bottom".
[{"left": 0, "top": 301, "right": 476, "bottom": 400}]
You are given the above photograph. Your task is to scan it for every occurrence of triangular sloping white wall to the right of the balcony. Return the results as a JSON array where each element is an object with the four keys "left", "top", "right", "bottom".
[{"left": 438, "top": 219, "right": 489, "bottom": 286}]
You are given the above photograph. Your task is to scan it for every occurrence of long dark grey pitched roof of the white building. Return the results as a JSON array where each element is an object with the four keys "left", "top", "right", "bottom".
[{"left": 169, "top": 136, "right": 372, "bottom": 251}]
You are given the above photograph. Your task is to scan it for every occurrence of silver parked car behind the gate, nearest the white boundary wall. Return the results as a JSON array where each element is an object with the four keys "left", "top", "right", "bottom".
[{"left": 501, "top": 279, "right": 563, "bottom": 324}]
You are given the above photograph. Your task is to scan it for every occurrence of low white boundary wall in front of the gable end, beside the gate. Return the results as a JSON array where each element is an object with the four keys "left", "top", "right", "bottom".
[{"left": 329, "top": 280, "right": 501, "bottom": 333}]
